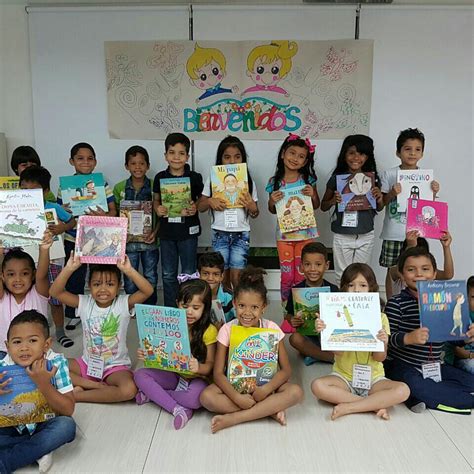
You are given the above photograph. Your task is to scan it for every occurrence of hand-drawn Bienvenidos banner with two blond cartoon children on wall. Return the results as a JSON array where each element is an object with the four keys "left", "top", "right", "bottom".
[{"left": 105, "top": 40, "right": 373, "bottom": 140}]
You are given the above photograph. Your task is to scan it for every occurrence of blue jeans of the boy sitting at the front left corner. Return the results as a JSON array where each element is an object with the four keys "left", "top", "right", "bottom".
[{"left": 0, "top": 416, "right": 76, "bottom": 474}]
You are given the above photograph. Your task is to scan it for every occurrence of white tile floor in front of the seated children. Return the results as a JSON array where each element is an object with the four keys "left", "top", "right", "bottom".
[{"left": 21, "top": 302, "right": 474, "bottom": 473}]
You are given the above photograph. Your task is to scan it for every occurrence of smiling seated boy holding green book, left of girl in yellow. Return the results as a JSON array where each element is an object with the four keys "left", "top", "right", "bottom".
[{"left": 285, "top": 242, "right": 339, "bottom": 365}]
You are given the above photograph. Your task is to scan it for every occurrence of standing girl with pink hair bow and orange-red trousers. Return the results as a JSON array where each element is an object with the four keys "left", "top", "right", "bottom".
[{"left": 266, "top": 134, "right": 319, "bottom": 306}]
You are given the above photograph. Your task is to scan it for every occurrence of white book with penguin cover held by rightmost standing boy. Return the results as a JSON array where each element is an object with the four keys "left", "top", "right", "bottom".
[{"left": 397, "top": 169, "right": 434, "bottom": 212}]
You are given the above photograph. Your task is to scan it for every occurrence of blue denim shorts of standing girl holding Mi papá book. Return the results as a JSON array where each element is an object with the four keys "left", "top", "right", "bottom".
[{"left": 212, "top": 229, "right": 250, "bottom": 270}]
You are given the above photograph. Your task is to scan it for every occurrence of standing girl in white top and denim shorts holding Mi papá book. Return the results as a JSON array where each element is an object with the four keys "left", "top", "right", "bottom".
[{"left": 198, "top": 135, "right": 258, "bottom": 288}]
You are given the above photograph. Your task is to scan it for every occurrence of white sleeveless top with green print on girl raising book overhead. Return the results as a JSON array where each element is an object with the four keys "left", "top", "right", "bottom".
[{"left": 77, "top": 295, "right": 132, "bottom": 369}]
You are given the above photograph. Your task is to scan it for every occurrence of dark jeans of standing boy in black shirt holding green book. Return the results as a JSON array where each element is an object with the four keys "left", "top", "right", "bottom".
[{"left": 160, "top": 237, "right": 197, "bottom": 307}]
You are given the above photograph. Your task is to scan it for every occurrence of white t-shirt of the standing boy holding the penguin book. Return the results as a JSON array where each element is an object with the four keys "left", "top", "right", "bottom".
[{"left": 380, "top": 166, "right": 407, "bottom": 242}]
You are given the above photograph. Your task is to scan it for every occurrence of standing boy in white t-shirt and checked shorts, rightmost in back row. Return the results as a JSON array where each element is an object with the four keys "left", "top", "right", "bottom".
[{"left": 379, "top": 128, "right": 439, "bottom": 298}]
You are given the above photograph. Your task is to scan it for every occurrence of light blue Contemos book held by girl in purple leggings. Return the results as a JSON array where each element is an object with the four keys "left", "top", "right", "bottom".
[{"left": 135, "top": 304, "right": 192, "bottom": 374}]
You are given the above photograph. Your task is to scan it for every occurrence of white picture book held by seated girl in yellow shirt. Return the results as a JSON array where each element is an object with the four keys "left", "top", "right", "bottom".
[{"left": 319, "top": 293, "right": 384, "bottom": 352}]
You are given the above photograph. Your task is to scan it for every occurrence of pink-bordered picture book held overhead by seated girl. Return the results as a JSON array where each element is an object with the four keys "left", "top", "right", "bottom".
[{"left": 75, "top": 216, "right": 128, "bottom": 264}]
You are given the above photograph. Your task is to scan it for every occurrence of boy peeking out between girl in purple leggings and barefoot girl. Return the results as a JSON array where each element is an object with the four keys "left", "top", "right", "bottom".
[{"left": 198, "top": 252, "right": 235, "bottom": 329}]
